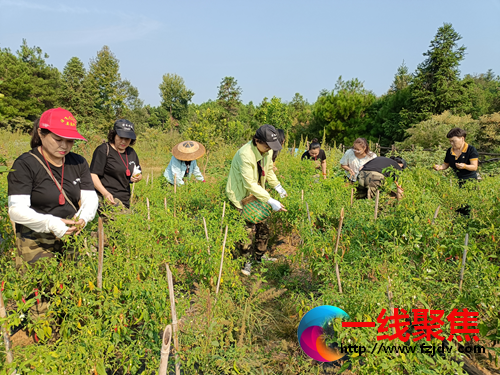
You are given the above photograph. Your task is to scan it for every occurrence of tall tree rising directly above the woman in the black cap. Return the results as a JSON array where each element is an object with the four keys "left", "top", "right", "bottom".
[{"left": 89, "top": 46, "right": 127, "bottom": 121}]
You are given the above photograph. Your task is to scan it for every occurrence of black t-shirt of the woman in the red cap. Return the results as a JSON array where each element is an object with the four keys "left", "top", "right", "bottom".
[{"left": 7, "top": 148, "right": 94, "bottom": 219}]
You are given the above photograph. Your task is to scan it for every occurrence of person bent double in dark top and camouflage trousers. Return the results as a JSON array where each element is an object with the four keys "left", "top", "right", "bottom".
[{"left": 358, "top": 156, "right": 407, "bottom": 199}]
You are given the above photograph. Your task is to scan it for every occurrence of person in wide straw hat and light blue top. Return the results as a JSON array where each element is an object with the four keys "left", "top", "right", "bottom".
[{"left": 163, "top": 141, "right": 205, "bottom": 186}]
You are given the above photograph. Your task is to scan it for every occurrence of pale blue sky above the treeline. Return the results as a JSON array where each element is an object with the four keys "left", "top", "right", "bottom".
[{"left": 0, "top": 0, "right": 500, "bottom": 106}]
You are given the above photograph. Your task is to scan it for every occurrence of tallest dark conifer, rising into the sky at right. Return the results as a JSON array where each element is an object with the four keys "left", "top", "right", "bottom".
[{"left": 410, "top": 23, "right": 471, "bottom": 123}]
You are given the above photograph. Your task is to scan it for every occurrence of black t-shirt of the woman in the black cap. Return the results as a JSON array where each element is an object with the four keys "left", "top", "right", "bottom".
[{"left": 90, "top": 143, "right": 140, "bottom": 208}]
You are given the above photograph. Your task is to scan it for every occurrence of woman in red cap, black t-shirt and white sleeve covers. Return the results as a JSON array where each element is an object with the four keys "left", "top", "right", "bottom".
[{"left": 7, "top": 108, "right": 98, "bottom": 267}]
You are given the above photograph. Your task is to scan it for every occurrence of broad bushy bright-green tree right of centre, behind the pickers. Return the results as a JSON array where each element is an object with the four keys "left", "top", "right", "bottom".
[{"left": 313, "top": 77, "right": 375, "bottom": 144}]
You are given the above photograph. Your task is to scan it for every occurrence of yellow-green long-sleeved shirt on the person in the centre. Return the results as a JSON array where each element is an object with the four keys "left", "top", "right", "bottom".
[{"left": 226, "top": 141, "right": 279, "bottom": 208}]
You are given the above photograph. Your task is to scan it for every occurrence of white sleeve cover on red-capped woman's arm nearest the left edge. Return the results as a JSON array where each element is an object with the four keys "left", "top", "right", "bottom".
[{"left": 8, "top": 195, "right": 68, "bottom": 238}]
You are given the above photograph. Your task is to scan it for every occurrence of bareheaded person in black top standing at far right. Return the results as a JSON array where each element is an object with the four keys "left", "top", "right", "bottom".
[{"left": 434, "top": 128, "right": 479, "bottom": 215}]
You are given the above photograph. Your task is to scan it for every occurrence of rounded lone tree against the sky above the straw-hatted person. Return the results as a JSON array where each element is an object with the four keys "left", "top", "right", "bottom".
[{"left": 159, "top": 73, "right": 194, "bottom": 120}]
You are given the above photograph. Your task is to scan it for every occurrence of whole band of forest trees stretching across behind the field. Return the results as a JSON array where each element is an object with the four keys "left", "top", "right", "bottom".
[{"left": 0, "top": 23, "right": 500, "bottom": 152}]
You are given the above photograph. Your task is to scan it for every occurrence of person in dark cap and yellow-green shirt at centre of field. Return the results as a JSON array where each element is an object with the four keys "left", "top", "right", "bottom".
[{"left": 226, "top": 125, "right": 287, "bottom": 276}]
